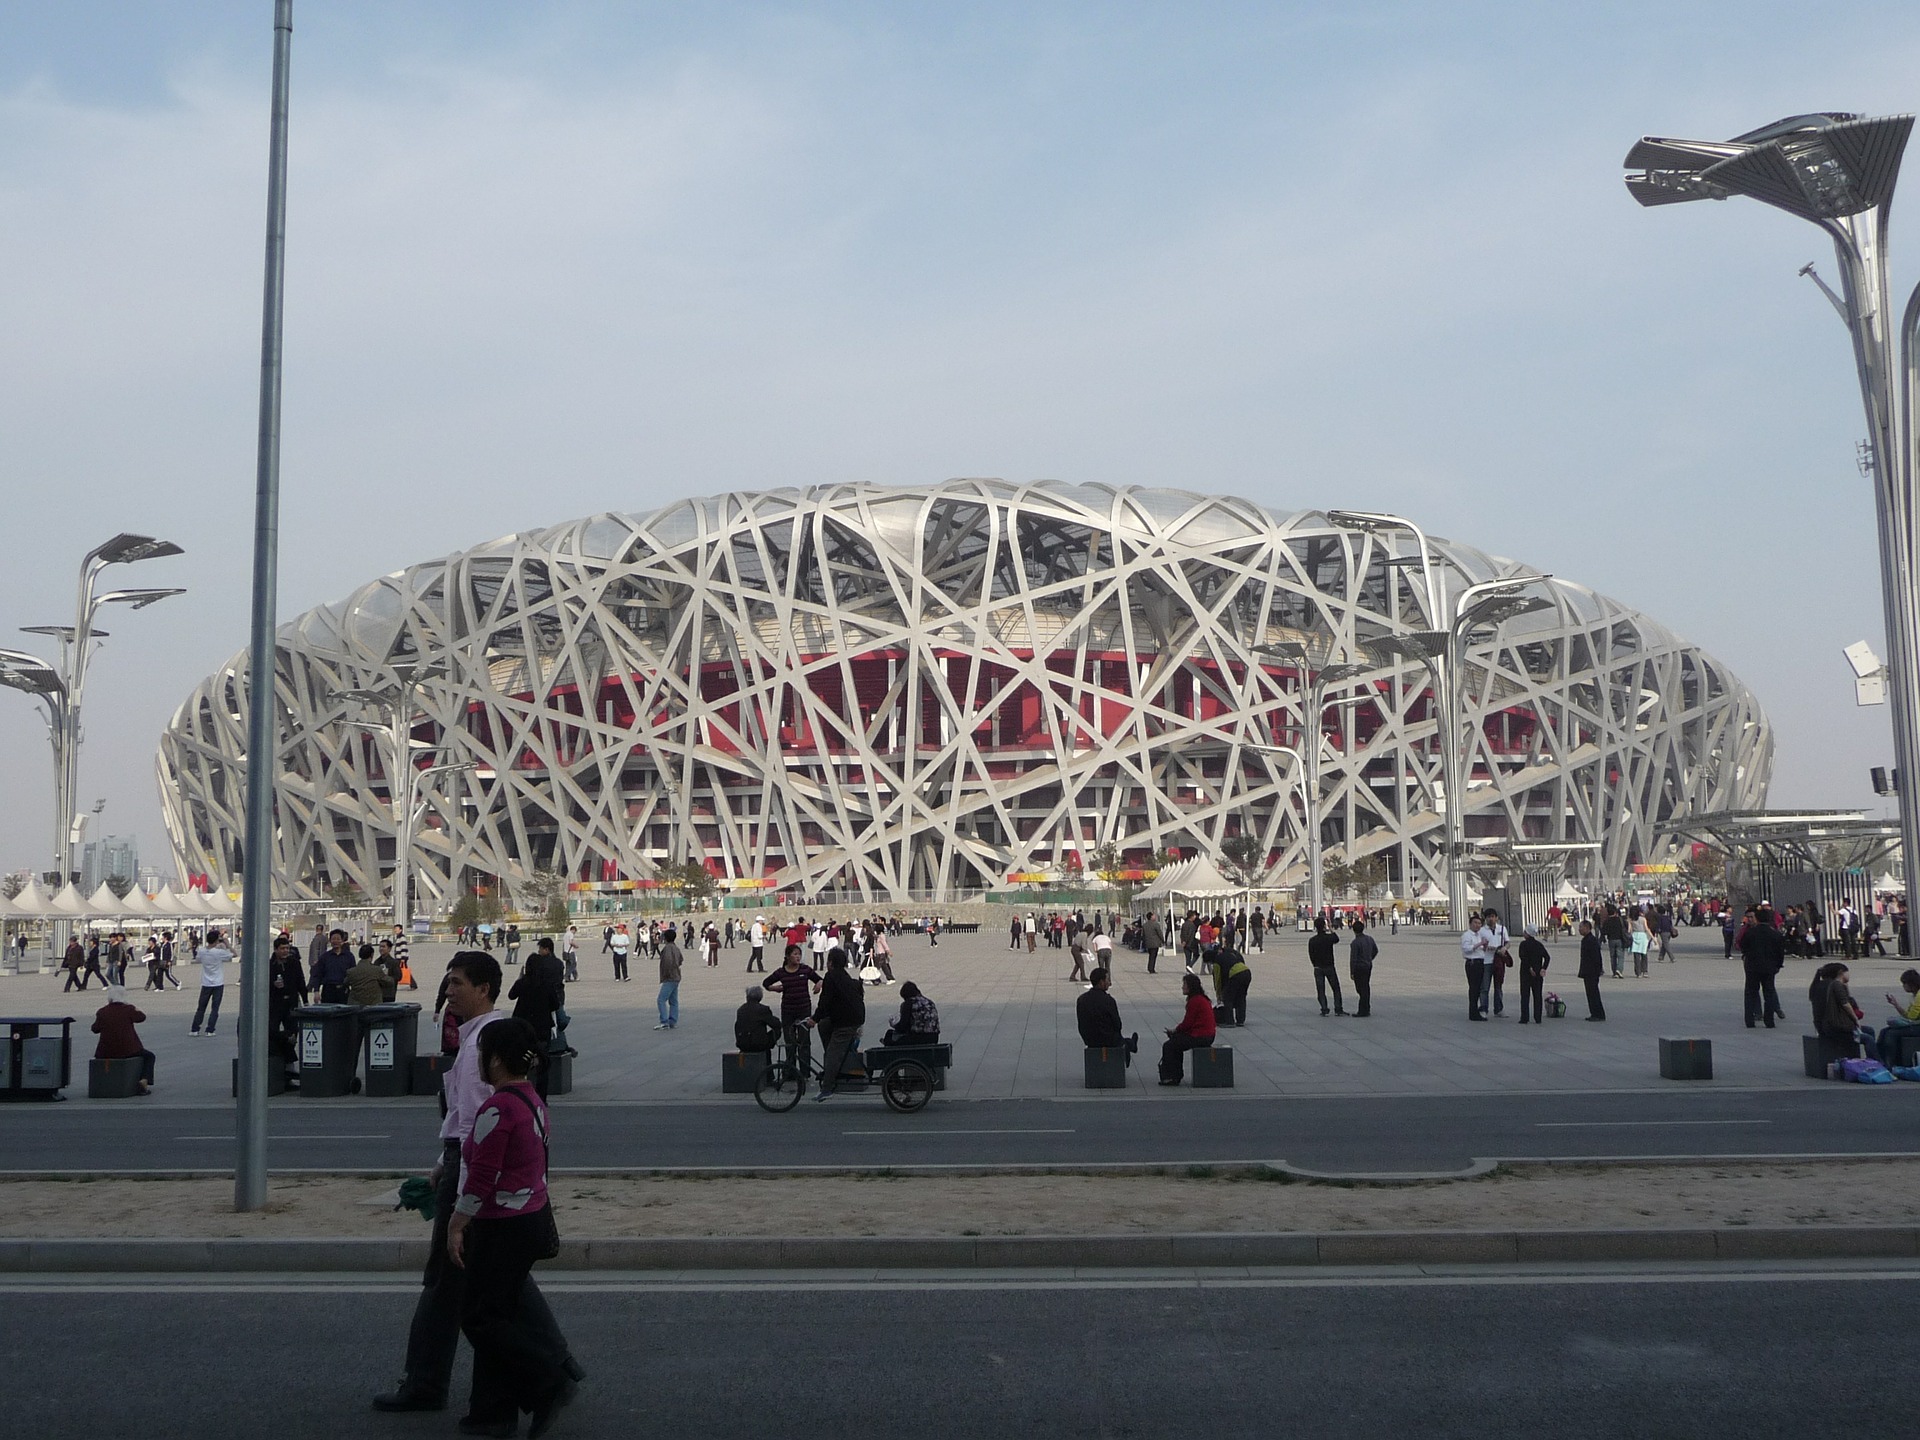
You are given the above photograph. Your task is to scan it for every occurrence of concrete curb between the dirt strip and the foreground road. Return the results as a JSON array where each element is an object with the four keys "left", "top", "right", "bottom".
[{"left": 0, "top": 1225, "right": 1920, "bottom": 1275}]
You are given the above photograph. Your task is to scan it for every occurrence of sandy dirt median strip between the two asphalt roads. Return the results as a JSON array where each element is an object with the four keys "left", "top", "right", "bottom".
[{"left": 0, "top": 1160, "right": 1920, "bottom": 1238}]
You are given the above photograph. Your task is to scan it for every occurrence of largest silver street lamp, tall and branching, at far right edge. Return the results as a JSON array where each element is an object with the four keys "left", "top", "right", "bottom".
[{"left": 1624, "top": 111, "right": 1920, "bottom": 885}]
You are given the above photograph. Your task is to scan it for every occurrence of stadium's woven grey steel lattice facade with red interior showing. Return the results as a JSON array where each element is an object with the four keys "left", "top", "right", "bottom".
[{"left": 159, "top": 480, "right": 1772, "bottom": 902}]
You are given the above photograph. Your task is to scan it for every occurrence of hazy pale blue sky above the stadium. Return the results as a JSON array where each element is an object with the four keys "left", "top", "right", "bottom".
[{"left": 0, "top": 0, "right": 1920, "bottom": 870}]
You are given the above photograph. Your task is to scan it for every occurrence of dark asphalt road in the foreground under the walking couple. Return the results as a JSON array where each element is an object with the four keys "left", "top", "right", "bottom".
[{"left": 0, "top": 1269, "right": 1920, "bottom": 1440}]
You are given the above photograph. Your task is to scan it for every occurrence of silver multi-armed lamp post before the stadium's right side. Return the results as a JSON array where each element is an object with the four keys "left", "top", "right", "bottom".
[{"left": 1327, "top": 511, "right": 1551, "bottom": 924}]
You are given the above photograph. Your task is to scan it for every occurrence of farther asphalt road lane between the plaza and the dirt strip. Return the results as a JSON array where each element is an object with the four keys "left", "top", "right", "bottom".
[{"left": 0, "top": 1085, "right": 1920, "bottom": 1173}]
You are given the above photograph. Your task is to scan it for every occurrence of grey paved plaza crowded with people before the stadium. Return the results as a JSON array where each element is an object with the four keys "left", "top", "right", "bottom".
[{"left": 0, "top": 927, "right": 1908, "bottom": 1106}]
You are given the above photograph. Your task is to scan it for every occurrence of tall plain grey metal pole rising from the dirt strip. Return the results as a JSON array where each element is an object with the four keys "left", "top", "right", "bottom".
[{"left": 234, "top": 0, "right": 294, "bottom": 1210}]
